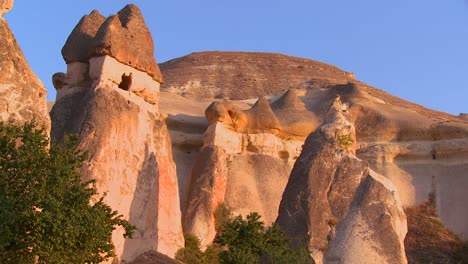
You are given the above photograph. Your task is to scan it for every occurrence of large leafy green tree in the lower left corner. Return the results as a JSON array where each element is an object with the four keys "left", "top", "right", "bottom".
[{"left": 0, "top": 122, "right": 134, "bottom": 263}]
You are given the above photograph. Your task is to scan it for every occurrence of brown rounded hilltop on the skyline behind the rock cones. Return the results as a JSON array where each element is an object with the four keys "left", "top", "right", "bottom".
[{"left": 159, "top": 51, "right": 353, "bottom": 100}]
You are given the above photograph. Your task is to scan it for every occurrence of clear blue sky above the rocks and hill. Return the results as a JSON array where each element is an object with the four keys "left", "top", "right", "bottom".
[{"left": 5, "top": 0, "right": 468, "bottom": 114}]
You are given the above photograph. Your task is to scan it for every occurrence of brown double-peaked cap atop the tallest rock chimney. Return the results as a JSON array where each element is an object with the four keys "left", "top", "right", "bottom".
[{"left": 62, "top": 4, "right": 162, "bottom": 83}]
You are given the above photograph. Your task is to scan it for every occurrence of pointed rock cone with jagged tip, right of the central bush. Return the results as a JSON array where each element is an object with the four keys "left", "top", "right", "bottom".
[{"left": 277, "top": 97, "right": 406, "bottom": 263}]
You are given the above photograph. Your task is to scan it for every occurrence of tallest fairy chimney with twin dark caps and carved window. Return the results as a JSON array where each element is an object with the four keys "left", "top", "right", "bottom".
[{"left": 51, "top": 5, "right": 184, "bottom": 262}]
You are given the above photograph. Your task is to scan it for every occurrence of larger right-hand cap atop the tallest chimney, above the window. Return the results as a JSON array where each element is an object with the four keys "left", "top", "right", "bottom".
[{"left": 89, "top": 4, "right": 162, "bottom": 83}]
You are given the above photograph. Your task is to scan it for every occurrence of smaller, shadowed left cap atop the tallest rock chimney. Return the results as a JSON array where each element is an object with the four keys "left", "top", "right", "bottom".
[{"left": 62, "top": 10, "right": 106, "bottom": 64}]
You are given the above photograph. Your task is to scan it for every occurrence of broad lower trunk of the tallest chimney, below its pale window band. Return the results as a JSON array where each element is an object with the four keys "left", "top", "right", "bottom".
[{"left": 52, "top": 82, "right": 184, "bottom": 262}]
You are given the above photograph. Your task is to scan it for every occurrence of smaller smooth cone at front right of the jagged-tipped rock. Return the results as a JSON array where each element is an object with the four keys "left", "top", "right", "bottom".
[{"left": 324, "top": 171, "right": 407, "bottom": 264}]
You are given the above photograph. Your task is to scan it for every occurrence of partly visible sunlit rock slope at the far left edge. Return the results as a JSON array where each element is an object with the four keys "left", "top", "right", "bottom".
[{"left": 0, "top": 0, "right": 50, "bottom": 133}]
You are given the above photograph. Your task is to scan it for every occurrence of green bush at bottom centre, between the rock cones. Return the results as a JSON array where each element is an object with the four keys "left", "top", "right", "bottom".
[{"left": 214, "top": 212, "right": 311, "bottom": 264}]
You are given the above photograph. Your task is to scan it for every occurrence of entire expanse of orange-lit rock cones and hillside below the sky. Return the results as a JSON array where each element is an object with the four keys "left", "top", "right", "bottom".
[{"left": 0, "top": 1, "right": 468, "bottom": 263}]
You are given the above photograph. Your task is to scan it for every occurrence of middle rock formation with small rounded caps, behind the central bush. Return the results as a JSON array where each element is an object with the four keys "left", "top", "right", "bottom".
[{"left": 183, "top": 95, "right": 302, "bottom": 246}]
